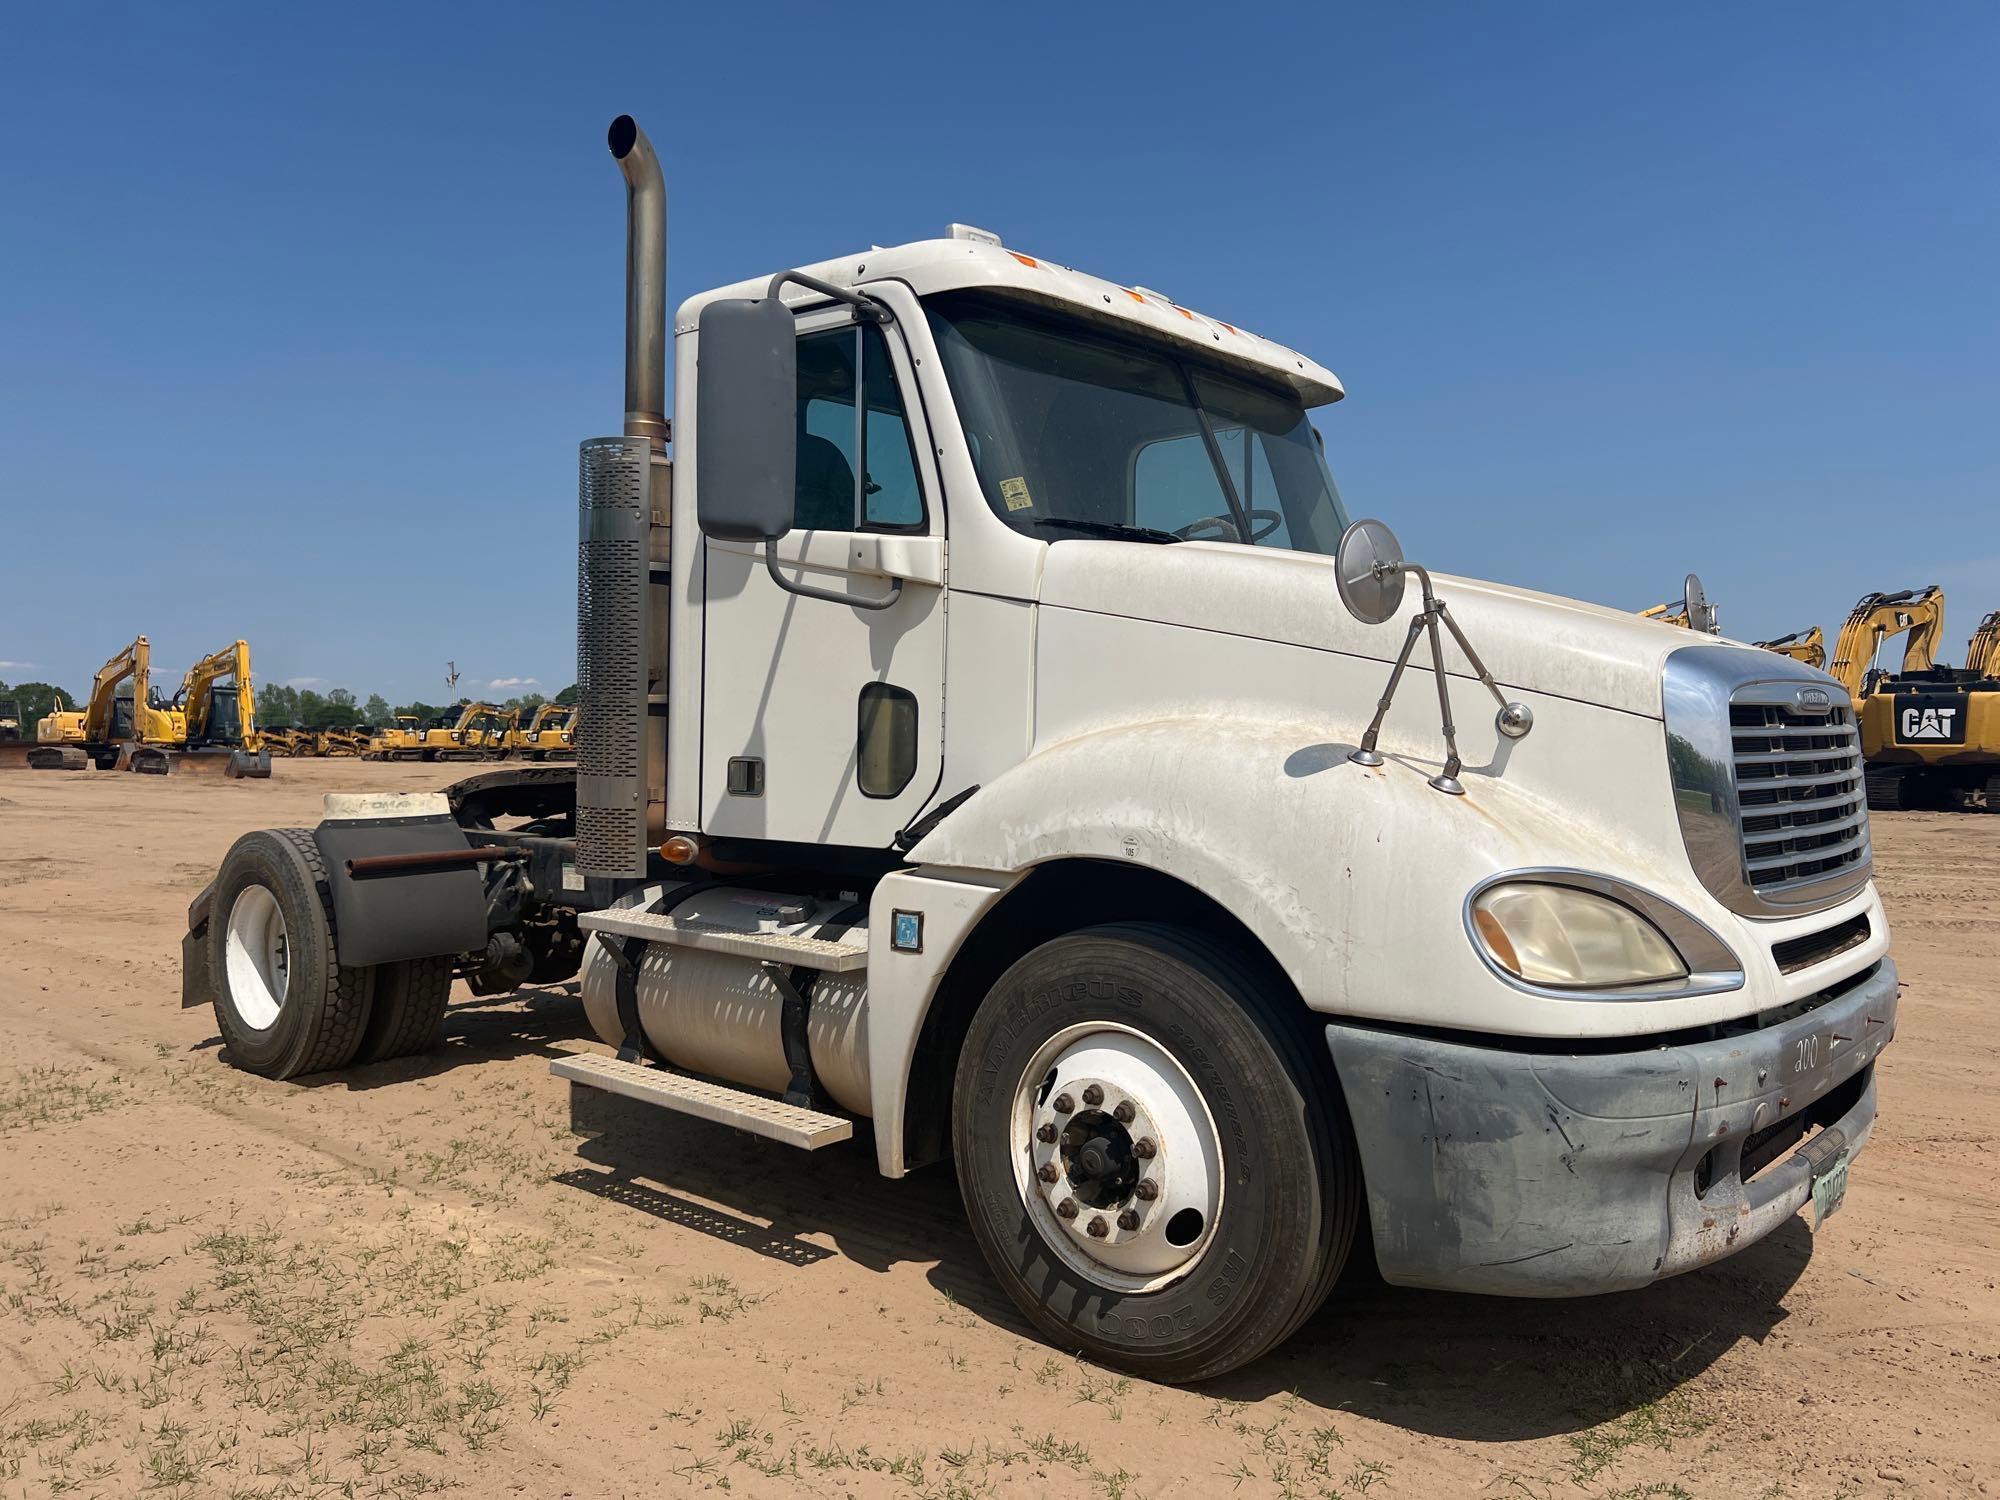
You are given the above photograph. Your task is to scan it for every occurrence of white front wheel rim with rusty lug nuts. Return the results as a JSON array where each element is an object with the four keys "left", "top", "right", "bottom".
[{"left": 1010, "top": 1022, "right": 1224, "bottom": 1292}]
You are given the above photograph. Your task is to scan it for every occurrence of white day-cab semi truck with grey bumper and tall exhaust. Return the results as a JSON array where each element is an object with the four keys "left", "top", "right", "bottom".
[{"left": 184, "top": 116, "right": 1898, "bottom": 1380}]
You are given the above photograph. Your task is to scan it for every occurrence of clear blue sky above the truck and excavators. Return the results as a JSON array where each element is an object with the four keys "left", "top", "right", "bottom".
[{"left": 0, "top": 4, "right": 2000, "bottom": 700}]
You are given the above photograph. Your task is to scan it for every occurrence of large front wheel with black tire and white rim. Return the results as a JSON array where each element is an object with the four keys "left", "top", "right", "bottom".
[{"left": 952, "top": 924, "right": 1360, "bottom": 1382}]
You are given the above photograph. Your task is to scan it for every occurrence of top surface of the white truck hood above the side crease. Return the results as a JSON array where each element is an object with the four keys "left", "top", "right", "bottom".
[{"left": 1040, "top": 538, "right": 1756, "bottom": 718}]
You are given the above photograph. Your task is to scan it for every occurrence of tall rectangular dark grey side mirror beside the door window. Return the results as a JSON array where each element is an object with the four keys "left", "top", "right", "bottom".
[{"left": 694, "top": 296, "right": 798, "bottom": 542}]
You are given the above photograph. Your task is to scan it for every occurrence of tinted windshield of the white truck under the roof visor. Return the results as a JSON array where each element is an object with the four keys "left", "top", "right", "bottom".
[{"left": 926, "top": 294, "right": 1346, "bottom": 554}]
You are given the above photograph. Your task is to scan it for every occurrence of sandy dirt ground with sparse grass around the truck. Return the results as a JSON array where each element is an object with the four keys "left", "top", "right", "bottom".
[{"left": 0, "top": 762, "right": 2000, "bottom": 1500}]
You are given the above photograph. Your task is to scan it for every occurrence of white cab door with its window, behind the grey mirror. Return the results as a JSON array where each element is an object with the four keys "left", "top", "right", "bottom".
[{"left": 700, "top": 308, "right": 944, "bottom": 848}]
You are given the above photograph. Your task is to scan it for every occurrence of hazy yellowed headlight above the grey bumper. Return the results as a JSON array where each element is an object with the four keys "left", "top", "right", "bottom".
[{"left": 1472, "top": 880, "right": 1688, "bottom": 988}]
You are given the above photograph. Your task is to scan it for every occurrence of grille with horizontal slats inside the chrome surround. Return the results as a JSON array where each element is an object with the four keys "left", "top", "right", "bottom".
[{"left": 1730, "top": 704, "right": 1868, "bottom": 894}]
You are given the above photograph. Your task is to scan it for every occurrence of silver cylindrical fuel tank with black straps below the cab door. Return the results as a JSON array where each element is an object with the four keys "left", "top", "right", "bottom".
[{"left": 582, "top": 884, "right": 870, "bottom": 1116}]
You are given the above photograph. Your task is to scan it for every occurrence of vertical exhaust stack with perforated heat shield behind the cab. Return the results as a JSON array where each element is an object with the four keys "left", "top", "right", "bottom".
[{"left": 576, "top": 114, "right": 672, "bottom": 882}]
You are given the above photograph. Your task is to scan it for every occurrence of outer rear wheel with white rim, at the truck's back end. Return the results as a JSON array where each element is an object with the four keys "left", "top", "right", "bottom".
[{"left": 208, "top": 828, "right": 374, "bottom": 1078}]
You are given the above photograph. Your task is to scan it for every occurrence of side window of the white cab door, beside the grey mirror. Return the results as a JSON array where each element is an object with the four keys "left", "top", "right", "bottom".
[{"left": 796, "top": 324, "right": 924, "bottom": 532}]
